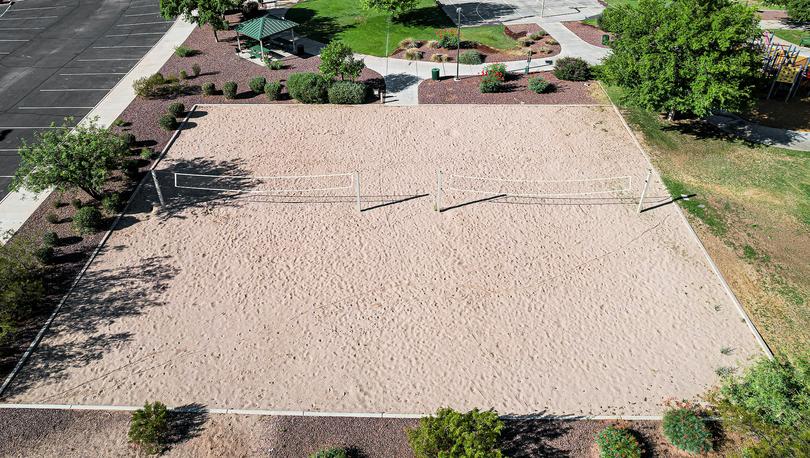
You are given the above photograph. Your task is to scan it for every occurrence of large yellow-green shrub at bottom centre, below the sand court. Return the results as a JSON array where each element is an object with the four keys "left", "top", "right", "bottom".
[{"left": 408, "top": 408, "right": 503, "bottom": 458}]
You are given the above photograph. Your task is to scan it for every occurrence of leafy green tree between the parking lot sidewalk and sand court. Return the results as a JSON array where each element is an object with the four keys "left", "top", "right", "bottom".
[{"left": 11, "top": 118, "right": 129, "bottom": 199}]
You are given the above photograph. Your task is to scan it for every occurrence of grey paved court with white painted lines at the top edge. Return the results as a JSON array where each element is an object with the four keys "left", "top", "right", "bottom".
[{"left": 439, "top": 0, "right": 604, "bottom": 26}]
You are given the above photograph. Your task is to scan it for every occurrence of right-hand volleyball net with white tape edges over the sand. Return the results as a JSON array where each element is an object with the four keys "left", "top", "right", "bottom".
[{"left": 442, "top": 174, "right": 633, "bottom": 197}]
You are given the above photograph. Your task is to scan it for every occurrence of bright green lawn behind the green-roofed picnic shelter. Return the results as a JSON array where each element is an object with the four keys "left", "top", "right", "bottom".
[{"left": 286, "top": 0, "right": 517, "bottom": 56}]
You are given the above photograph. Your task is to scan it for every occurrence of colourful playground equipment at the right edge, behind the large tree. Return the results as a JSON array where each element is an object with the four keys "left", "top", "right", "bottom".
[{"left": 760, "top": 32, "right": 810, "bottom": 102}]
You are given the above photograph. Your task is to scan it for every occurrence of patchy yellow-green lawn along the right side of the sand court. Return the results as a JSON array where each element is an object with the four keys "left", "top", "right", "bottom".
[{"left": 608, "top": 88, "right": 810, "bottom": 353}]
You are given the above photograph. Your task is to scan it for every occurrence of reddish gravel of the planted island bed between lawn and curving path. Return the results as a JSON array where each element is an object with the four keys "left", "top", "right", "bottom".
[{"left": 391, "top": 24, "right": 562, "bottom": 63}]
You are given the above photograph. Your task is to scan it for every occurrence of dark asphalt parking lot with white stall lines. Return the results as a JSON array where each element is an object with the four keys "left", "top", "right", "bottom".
[{"left": 0, "top": 0, "right": 172, "bottom": 200}]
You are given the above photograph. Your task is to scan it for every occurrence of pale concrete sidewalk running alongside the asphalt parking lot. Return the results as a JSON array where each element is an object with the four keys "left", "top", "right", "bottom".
[{"left": 0, "top": 18, "right": 194, "bottom": 243}]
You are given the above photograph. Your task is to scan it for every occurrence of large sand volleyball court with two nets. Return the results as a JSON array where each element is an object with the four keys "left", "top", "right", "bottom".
[{"left": 7, "top": 105, "right": 761, "bottom": 415}]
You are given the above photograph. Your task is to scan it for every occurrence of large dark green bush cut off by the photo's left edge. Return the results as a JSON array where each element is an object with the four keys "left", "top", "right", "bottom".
[{"left": 0, "top": 236, "right": 45, "bottom": 343}]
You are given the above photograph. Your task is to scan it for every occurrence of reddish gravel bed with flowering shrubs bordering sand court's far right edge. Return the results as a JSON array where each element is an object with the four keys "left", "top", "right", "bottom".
[{"left": 419, "top": 72, "right": 600, "bottom": 105}]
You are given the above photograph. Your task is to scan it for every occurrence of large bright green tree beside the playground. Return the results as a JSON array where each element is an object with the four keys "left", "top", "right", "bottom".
[{"left": 601, "top": 0, "right": 762, "bottom": 119}]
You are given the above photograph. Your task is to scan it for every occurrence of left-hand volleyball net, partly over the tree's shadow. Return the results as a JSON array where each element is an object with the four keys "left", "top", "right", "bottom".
[{"left": 174, "top": 173, "right": 355, "bottom": 194}]
